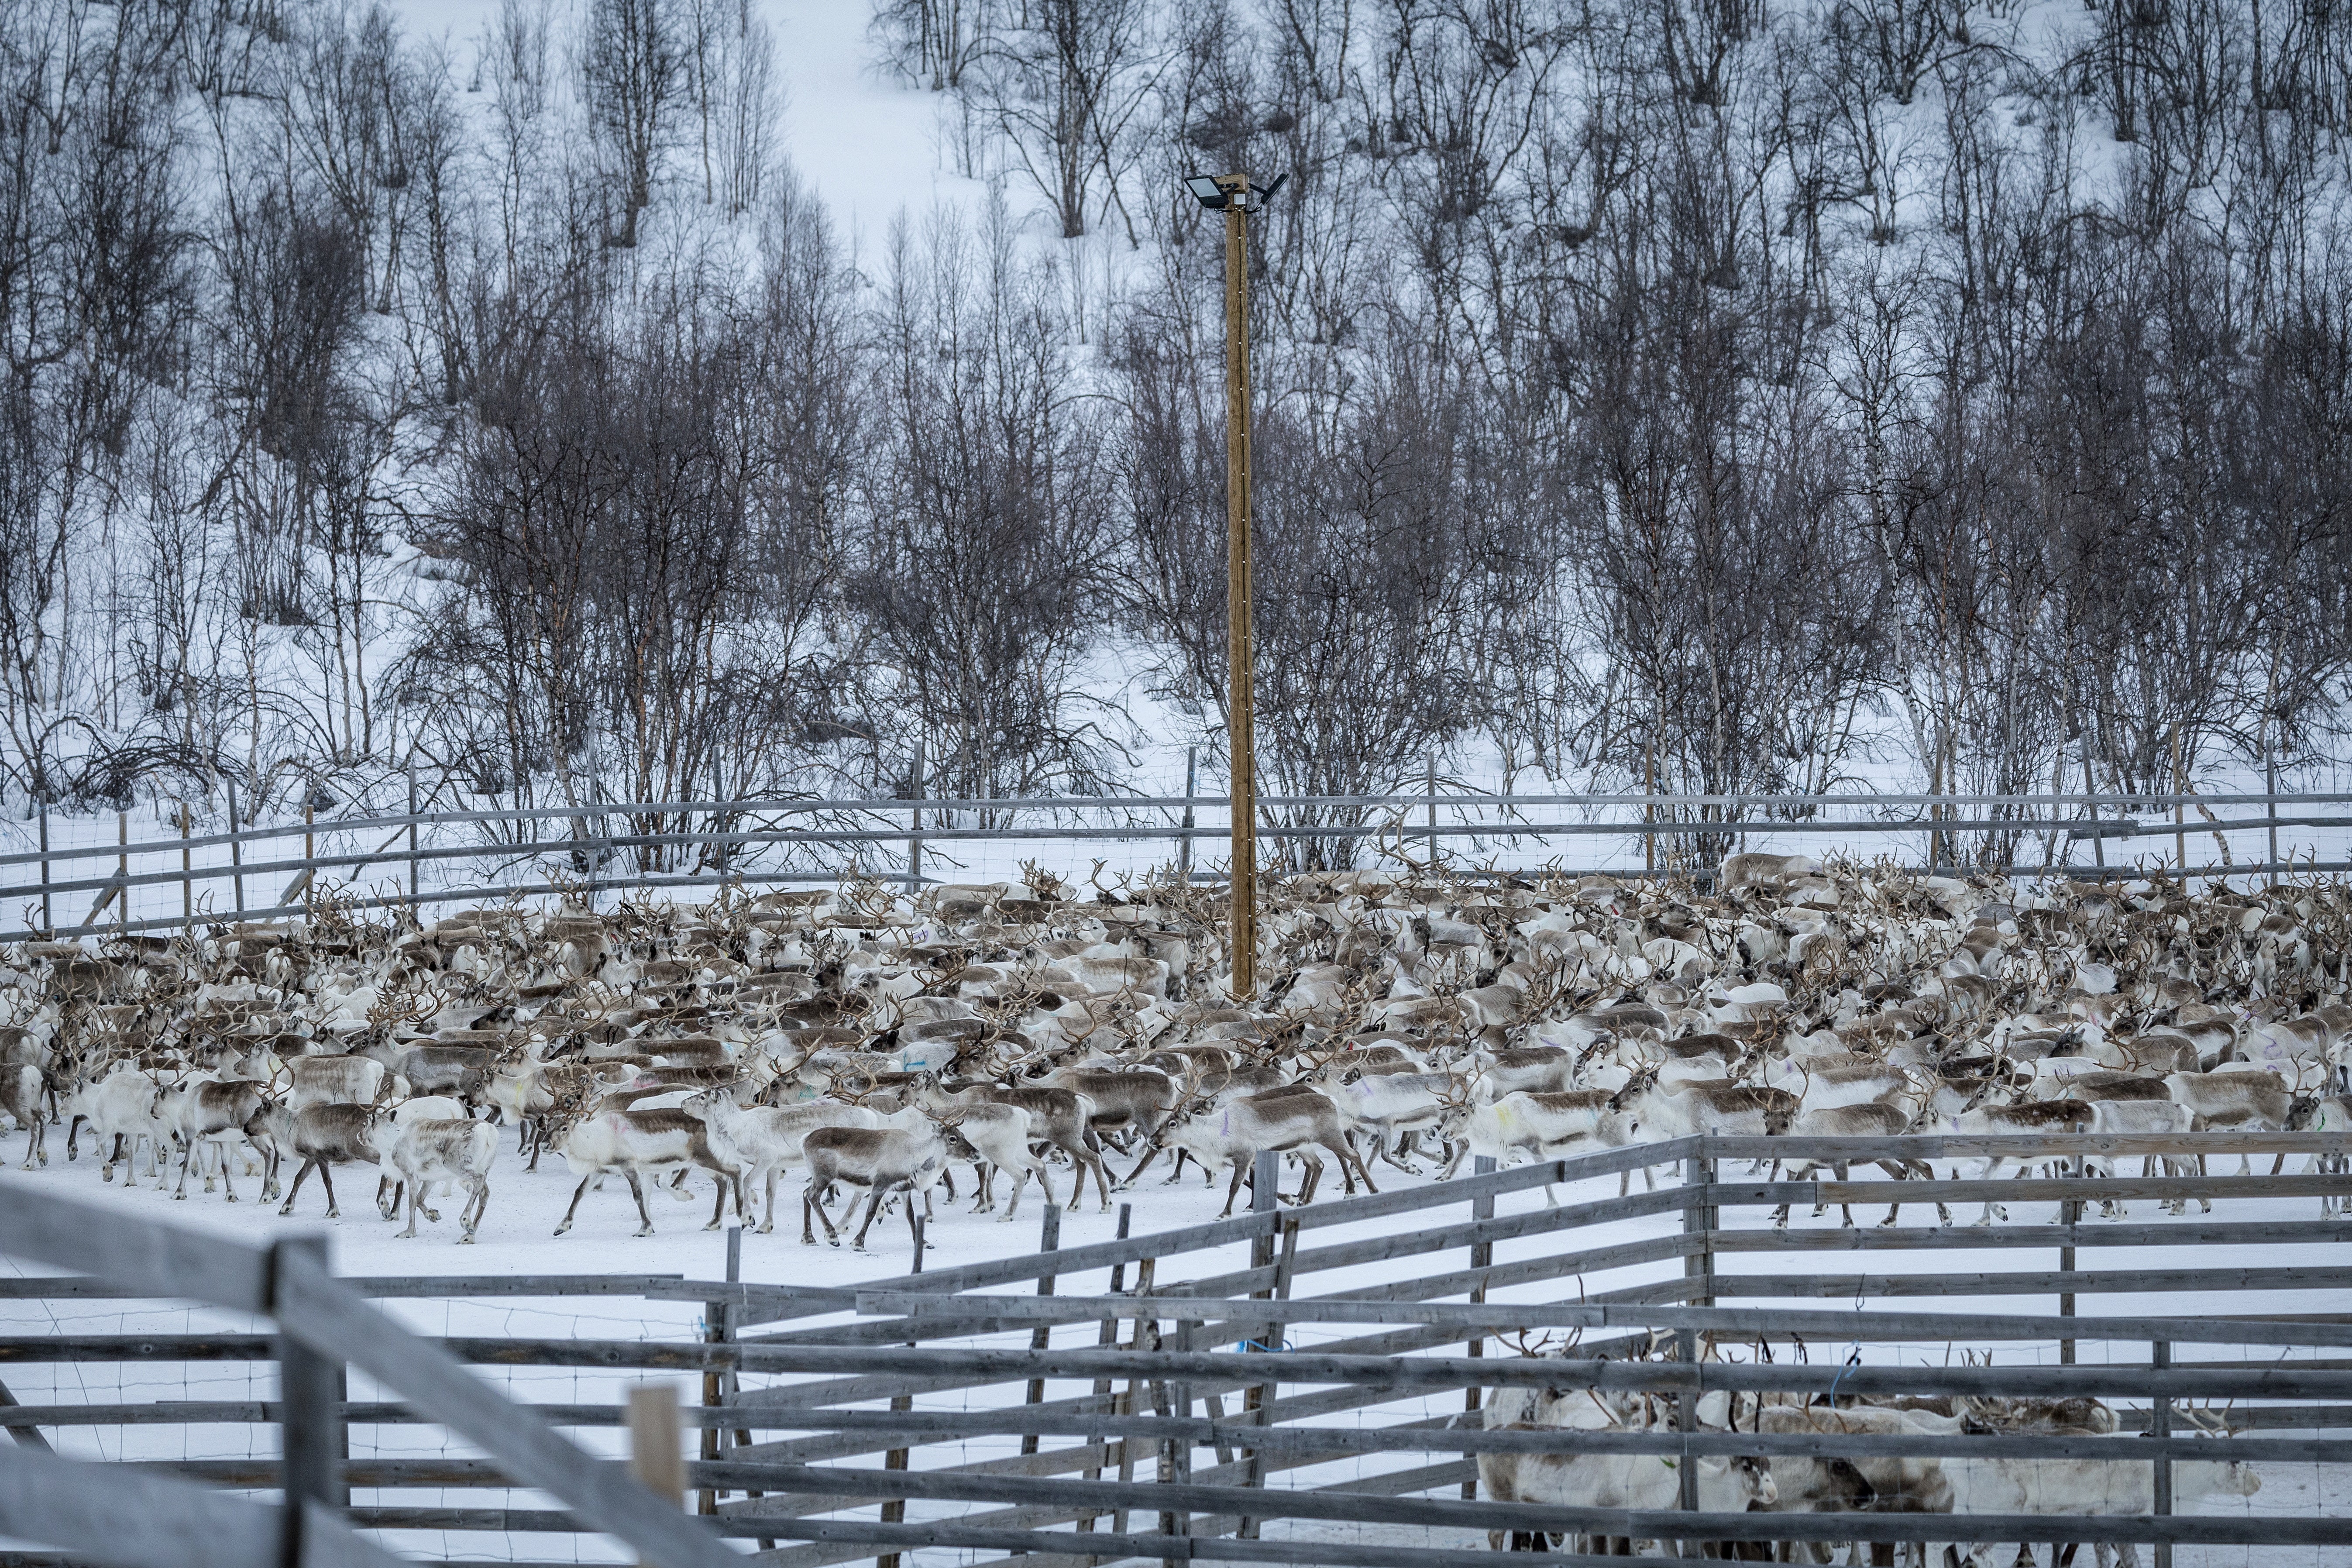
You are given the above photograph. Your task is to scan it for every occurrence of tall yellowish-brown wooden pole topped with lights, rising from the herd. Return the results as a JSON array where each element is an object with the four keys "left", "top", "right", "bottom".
[{"left": 1186, "top": 174, "right": 1289, "bottom": 999}]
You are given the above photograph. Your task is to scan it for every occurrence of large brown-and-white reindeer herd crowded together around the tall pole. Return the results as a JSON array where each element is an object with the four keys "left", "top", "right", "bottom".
[{"left": 0, "top": 856, "right": 2352, "bottom": 1248}]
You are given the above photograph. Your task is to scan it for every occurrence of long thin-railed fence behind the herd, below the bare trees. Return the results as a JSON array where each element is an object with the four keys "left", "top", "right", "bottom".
[{"left": 0, "top": 774, "right": 2352, "bottom": 943}]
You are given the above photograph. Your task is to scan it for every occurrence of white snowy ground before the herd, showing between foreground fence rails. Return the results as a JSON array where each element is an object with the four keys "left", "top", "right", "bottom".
[{"left": 0, "top": 1140, "right": 2352, "bottom": 1568}]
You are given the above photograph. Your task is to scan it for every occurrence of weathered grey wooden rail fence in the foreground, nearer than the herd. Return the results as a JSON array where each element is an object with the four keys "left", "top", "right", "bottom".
[{"left": 0, "top": 1133, "right": 2352, "bottom": 1568}]
